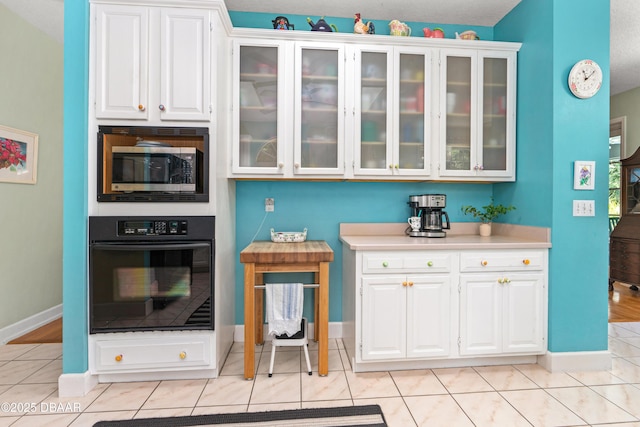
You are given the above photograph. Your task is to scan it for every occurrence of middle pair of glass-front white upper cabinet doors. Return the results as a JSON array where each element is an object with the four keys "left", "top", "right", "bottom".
[{"left": 349, "top": 46, "right": 433, "bottom": 178}]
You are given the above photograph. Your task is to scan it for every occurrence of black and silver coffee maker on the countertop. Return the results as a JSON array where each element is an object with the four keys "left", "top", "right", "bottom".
[{"left": 407, "top": 194, "right": 451, "bottom": 237}]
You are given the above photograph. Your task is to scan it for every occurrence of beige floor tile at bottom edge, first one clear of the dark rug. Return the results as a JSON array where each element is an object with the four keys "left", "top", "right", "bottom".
[{"left": 404, "top": 394, "right": 476, "bottom": 427}]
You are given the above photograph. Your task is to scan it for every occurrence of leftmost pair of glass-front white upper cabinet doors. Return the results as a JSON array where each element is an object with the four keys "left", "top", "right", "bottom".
[{"left": 232, "top": 39, "right": 345, "bottom": 178}]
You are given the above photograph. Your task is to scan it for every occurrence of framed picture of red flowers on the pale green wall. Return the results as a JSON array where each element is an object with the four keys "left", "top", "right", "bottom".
[{"left": 0, "top": 125, "right": 38, "bottom": 184}]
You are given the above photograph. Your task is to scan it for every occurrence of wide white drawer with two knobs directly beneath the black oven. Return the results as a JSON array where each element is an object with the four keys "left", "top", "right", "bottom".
[{"left": 96, "top": 339, "right": 211, "bottom": 372}]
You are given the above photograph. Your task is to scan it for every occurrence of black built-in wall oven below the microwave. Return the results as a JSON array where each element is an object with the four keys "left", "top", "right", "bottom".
[{"left": 89, "top": 216, "right": 215, "bottom": 334}]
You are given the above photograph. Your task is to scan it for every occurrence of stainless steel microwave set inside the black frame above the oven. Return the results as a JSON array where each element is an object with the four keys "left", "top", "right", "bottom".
[{"left": 111, "top": 148, "right": 202, "bottom": 193}]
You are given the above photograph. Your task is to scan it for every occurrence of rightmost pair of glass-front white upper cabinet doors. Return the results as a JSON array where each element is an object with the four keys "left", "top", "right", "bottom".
[{"left": 439, "top": 49, "right": 516, "bottom": 181}]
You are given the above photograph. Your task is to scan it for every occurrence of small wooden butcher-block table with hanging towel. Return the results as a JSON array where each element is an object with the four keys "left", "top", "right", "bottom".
[{"left": 240, "top": 240, "right": 333, "bottom": 379}]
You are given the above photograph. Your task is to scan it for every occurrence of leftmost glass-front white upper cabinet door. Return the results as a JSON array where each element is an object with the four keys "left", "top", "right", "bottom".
[{"left": 233, "top": 43, "right": 283, "bottom": 173}]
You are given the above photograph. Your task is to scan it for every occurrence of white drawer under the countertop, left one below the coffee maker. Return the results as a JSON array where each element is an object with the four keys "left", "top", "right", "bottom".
[{"left": 362, "top": 251, "right": 454, "bottom": 273}]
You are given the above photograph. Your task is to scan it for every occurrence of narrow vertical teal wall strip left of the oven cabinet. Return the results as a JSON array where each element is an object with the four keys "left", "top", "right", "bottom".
[{"left": 62, "top": 0, "right": 89, "bottom": 374}]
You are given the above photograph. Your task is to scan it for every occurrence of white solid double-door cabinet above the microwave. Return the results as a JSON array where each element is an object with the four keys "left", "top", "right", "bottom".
[{"left": 95, "top": 4, "right": 211, "bottom": 121}]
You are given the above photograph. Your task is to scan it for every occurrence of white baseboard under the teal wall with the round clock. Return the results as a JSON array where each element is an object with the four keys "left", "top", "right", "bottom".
[{"left": 538, "top": 350, "right": 611, "bottom": 372}]
